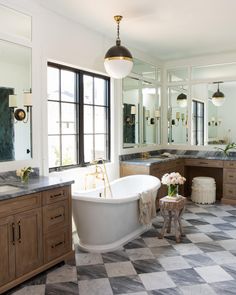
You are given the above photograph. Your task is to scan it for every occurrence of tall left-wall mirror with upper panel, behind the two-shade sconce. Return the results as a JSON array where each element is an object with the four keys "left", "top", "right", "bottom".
[{"left": 0, "top": 5, "right": 32, "bottom": 162}]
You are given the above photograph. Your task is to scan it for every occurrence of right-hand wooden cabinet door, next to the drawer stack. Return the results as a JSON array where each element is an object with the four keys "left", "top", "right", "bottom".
[{"left": 15, "top": 208, "right": 43, "bottom": 277}]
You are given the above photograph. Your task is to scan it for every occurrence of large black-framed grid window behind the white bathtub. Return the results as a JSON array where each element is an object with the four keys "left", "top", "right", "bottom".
[{"left": 48, "top": 62, "right": 110, "bottom": 171}]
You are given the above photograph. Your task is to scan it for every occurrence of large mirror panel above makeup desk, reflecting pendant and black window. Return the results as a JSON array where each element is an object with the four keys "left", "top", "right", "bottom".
[{"left": 191, "top": 81, "right": 236, "bottom": 145}]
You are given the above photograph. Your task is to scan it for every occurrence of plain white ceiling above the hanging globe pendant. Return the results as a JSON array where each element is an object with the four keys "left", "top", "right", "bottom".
[{"left": 36, "top": 0, "right": 236, "bottom": 60}]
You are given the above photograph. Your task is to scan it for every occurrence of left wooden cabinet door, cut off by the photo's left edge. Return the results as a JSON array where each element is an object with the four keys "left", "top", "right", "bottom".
[{"left": 0, "top": 216, "right": 15, "bottom": 286}]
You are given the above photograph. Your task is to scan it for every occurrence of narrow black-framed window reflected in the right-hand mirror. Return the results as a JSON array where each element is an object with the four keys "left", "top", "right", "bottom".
[{"left": 192, "top": 100, "right": 204, "bottom": 145}]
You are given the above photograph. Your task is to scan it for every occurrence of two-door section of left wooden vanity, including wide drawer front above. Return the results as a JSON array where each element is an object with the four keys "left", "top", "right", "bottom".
[{"left": 0, "top": 193, "right": 42, "bottom": 291}]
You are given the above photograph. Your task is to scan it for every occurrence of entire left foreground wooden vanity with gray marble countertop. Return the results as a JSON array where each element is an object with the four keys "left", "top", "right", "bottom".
[{"left": 0, "top": 177, "right": 73, "bottom": 294}]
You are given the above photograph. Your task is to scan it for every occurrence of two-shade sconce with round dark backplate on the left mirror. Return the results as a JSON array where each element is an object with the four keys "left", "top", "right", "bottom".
[{"left": 9, "top": 89, "right": 32, "bottom": 123}]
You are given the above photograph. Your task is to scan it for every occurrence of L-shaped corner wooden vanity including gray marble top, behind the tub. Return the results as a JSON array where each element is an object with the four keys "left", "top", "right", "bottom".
[{"left": 120, "top": 150, "right": 236, "bottom": 204}]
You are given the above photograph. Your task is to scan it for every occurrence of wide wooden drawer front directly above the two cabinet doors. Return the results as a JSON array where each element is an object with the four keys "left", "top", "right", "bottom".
[{"left": 0, "top": 193, "right": 41, "bottom": 217}]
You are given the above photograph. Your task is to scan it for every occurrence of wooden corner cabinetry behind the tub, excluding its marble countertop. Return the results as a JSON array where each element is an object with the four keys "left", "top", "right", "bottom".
[{"left": 121, "top": 158, "right": 236, "bottom": 205}]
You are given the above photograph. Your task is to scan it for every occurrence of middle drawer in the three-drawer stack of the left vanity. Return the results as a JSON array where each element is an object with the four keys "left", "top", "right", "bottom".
[{"left": 43, "top": 200, "right": 69, "bottom": 233}]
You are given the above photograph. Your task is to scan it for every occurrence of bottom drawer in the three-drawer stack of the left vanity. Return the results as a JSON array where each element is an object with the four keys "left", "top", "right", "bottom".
[{"left": 44, "top": 226, "right": 71, "bottom": 262}]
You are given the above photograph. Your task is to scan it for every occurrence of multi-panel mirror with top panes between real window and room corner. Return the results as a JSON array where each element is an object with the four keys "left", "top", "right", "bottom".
[{"left": 122, "top": 59, "right": 161, "bottom": 148}]
